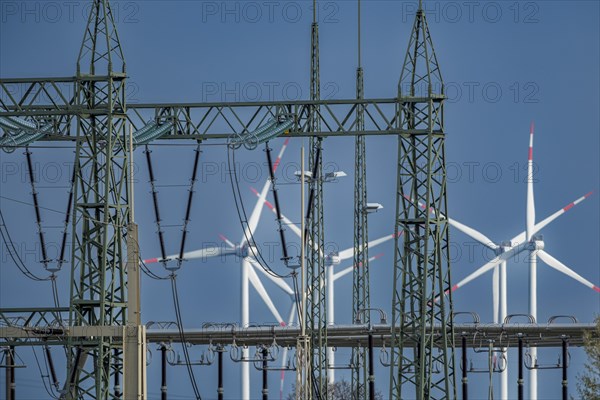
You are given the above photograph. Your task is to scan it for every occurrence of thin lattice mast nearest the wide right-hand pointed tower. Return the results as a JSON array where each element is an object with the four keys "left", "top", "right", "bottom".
[{"left": 352, "top": 0, "right": 371, "bottom": 399}]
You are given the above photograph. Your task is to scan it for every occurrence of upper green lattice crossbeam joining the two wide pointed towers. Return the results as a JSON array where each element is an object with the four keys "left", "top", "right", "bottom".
[{"left": 0, "top": 76, "right": 445, "bottom": 141}]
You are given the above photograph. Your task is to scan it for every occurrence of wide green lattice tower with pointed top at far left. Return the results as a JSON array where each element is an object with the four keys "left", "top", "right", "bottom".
[{"left": 66, "top": 0, "right": 130, "bottom": 399}]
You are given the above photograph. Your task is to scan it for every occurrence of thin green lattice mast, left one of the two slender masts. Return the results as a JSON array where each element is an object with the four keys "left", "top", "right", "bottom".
[{"left": 306, "top": 0, "right": 327, "bottom": 399}]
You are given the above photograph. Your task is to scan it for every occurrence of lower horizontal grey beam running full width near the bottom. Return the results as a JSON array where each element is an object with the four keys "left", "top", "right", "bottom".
[{"left": 0, "top": 323, "right": 595, "bottom": 348}]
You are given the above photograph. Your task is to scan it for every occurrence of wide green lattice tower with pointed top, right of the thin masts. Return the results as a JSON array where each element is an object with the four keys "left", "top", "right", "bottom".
[{"left": 390, "top": 2, "right": 456, "bottom": 399}]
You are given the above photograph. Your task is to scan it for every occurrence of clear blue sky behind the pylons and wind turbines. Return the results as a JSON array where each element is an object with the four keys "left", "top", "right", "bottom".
[{"left": 0, "top": 0, "right": 600, "bottom": 399}]
